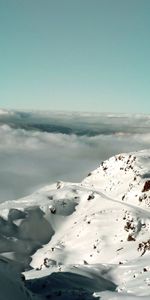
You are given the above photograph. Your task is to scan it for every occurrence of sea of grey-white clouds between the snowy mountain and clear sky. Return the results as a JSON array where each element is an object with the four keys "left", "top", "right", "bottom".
[{"left": 0, "top": 110, "right": 150, "bottom": 202}]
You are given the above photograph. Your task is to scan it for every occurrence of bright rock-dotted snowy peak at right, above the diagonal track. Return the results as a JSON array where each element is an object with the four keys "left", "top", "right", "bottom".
[{"left": 82, "top": 150, "right": 150, "bottom": 206}]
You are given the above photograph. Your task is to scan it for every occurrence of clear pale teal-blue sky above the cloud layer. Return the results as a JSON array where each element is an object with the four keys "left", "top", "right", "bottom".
[{"left": 0, "top": 0, "right": 150, "bottom": 113}]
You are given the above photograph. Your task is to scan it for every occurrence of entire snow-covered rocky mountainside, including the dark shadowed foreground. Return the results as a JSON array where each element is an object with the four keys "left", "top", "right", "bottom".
[{"left": 0, "top": 150, "right": 150, "bottom": 300}]
